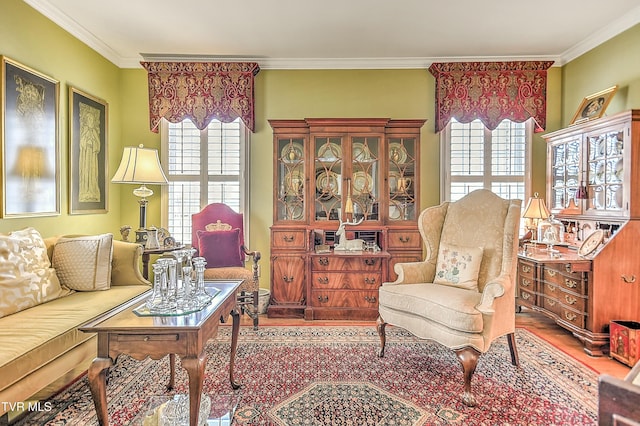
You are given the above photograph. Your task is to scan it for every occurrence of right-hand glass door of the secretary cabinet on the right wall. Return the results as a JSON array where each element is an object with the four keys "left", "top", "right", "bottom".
[{"left": 587, "top": 126, "right": 624, "bottom": 213}]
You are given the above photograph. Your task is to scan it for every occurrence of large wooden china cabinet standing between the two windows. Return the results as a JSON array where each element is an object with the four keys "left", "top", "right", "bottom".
[{"left": 268, "top": 118, "right": 425, "bottom": 319}]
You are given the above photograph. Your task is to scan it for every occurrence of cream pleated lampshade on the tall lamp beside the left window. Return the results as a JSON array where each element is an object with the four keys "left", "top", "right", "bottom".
[{"left": 111, "top": 145, "right": 167, "bottom": 185}]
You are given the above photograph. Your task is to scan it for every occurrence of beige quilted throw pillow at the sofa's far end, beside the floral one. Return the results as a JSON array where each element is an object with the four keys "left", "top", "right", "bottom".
[{"left": 53, "top": 234, "right": 113, "bottom": 291}]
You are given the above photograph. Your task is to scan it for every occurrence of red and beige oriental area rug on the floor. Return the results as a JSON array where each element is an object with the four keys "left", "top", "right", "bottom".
[{"left": 18, "top": 325, "right": 598, "bottom": 426}]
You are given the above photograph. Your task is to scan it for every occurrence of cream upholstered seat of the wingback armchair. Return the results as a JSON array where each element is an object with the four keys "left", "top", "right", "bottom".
[{"left": 379, "top": 284, "right": 483, "bottom": 333}]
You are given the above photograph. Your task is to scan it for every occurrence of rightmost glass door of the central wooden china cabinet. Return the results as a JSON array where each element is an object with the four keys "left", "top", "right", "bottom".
[{"left": 387, "top": 138, "right": 416, "bottom": 221}]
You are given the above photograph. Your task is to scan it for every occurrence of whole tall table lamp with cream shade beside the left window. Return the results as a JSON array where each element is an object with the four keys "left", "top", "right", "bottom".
[{"left": 111, "top": 144, "right": 167, "bottom": 245}]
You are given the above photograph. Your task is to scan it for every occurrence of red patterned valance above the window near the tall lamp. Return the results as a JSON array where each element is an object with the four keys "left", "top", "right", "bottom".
[{"left": 141, "top": 62, "right": 260, "bottom": 133}]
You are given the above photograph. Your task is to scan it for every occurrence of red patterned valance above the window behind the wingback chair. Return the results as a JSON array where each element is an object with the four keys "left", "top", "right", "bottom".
[{"left": 429, "top": 61, "right": 553, "bottom": 132}]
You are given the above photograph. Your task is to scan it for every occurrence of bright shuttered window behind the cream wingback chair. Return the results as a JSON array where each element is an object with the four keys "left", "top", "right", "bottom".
[{"left": 440, "top": 119, "right": 533, "bottom": 201}]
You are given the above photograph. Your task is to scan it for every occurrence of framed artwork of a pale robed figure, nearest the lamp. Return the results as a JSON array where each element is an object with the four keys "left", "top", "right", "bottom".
[{"left": 69, "top": 87, "right": 109, "bottom": 214}]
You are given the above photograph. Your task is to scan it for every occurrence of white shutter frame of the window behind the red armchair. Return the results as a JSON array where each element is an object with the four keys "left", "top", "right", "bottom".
[{"left": 160, "top": 119, "right": 251, "bottom": 247}]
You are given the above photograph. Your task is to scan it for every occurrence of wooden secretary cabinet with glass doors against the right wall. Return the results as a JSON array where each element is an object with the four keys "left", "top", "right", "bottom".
[{"left": 517, "top": 110, "right": 640, "bottom": 355}]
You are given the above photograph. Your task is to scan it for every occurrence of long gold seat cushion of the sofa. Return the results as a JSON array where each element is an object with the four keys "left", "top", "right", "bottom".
[{"left": 0, "top": 285, "right": 149, "bottom": 390}]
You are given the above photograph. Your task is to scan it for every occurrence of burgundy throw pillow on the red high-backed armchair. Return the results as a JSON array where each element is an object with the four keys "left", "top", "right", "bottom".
[{"left": 196, "top": 228, "right": 242, "bottom": 268}]
